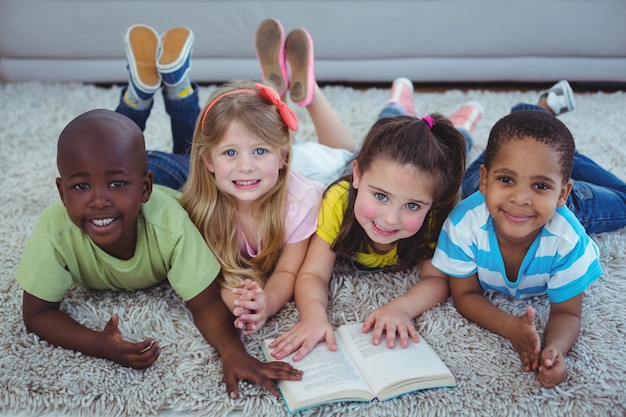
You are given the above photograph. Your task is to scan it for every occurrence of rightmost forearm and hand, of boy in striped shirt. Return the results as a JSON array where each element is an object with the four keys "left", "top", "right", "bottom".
[{"left": 537, "top": 293, "right": 583, "bottom": 388}]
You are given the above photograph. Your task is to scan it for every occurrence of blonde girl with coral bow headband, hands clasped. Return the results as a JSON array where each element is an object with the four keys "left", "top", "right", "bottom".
[{"left": 181, "top": 81, "right": 323, "bottom": 333}]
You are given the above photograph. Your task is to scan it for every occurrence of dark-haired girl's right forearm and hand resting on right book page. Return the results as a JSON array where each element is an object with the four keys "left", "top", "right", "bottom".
[{"left": 363, "top": 259, "right": 450, "bottom": 348}]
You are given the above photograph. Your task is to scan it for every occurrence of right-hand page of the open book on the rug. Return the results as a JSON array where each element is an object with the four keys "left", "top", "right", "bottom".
[{"left": 338, "top": 323, "right": 455, "bottom": 400}]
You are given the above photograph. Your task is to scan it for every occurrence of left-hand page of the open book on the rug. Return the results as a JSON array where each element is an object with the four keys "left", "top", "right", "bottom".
[{"left": 263, "top": 339, "right": 374, "bottom": 410}]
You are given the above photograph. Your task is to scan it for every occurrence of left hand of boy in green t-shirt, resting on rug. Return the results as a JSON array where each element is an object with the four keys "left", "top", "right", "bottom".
[{"left": 98, "top": 314, "right": 161, "bottom": 369}]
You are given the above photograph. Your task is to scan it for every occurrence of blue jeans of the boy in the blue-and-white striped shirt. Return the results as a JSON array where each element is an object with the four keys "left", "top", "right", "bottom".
[{"left": 462, "top": 103, "right": 626, "bottom": 234}]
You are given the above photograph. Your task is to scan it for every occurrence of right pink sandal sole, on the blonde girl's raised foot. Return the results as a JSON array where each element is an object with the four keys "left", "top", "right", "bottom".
[{"left": 285, "top": 28, "right": 315, "bottom": 107}]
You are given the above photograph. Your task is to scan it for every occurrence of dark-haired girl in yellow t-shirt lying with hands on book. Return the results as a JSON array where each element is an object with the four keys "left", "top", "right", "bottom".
[{"left": 270, "top": 78, "right": 472, "bottom": 360}]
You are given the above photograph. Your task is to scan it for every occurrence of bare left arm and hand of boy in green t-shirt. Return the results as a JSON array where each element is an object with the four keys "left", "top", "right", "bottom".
[{"left": 22, "top": 291, "right": 161, "bottom": 369}]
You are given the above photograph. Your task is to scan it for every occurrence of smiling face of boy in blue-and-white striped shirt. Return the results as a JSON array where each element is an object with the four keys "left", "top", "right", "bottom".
[{"left": 480, "top": 138, "right": 571, "bottom": 244}]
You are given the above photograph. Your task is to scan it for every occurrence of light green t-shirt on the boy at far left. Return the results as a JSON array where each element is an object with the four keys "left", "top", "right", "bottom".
[{"left": 15, "top": 185, "right": 220, "bottom": 302}]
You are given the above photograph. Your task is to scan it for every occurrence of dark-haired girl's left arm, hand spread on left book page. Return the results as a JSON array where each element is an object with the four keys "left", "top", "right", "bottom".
[{"left": 270, "top": 235, "right": 337, "bottom": 361}]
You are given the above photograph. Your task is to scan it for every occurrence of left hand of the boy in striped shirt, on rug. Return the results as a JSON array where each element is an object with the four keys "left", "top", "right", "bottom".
[{"left": 507, "top": 306, "right": 541, "bottom": 372}]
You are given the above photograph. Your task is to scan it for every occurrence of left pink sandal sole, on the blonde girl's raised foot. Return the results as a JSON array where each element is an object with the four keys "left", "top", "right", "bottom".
[{"left": 254, "top": 19, "right": 287, "bottom": 97}]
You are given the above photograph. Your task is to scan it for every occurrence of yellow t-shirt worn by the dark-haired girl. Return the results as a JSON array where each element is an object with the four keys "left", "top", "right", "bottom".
[{"left": 317, "top": 181, "right": 398, "bottom": 269}]
